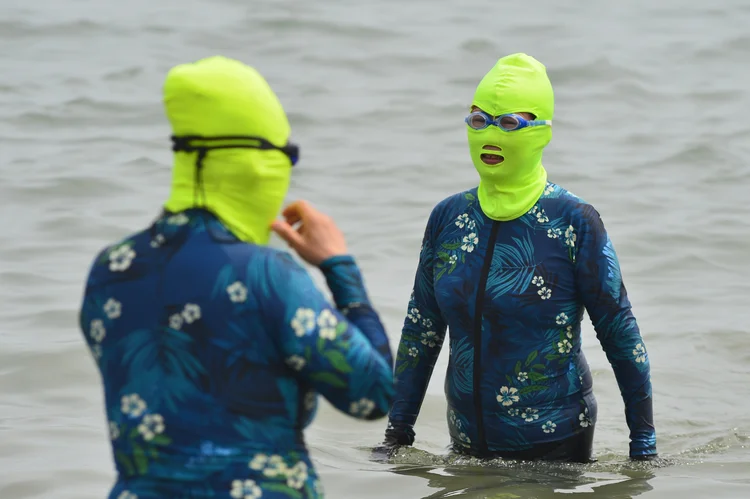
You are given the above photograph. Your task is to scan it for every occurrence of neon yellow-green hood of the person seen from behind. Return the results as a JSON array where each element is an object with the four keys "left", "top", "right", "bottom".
[{"left": 164, "top": 56, "right": 292, "bottom": 244}]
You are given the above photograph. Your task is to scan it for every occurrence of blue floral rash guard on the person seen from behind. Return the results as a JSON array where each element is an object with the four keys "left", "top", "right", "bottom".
[{"left": 80, "top": 209, "right": 394, "bottom": 499}]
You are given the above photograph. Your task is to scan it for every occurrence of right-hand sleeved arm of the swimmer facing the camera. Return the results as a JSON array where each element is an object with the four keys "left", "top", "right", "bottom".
[{"left": 576, "top": 207, "right": 656, "bottom": 459}]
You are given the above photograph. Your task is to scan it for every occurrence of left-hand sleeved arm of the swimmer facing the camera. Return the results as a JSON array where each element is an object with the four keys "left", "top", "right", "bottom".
[{"left": 385, "top": 211, "right": 446, "bottom": 445}]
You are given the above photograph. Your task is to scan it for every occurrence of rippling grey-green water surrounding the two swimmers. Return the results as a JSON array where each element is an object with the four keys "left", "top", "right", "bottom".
[{"left": 0, "top": 0, "right": 750, "bottom": 499}]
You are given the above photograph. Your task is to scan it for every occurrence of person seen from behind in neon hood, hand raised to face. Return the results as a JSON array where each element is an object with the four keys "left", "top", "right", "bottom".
[{"left": 80, "top": 57, "right": 393, "bottom": 499}]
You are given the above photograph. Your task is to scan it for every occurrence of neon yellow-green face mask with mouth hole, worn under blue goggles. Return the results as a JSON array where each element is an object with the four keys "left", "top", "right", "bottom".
[{"left": 467, "top": 54, "right": 554, "bottom": 221}]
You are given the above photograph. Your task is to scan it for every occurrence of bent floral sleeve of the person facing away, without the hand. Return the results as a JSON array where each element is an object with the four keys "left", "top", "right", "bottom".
[{"left": 271, "top": 255, "right": 400, "bottom": 420}]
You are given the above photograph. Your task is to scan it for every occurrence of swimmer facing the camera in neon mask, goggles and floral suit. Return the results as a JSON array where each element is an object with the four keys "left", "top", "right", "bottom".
[{"left": 386, "top": 54, "right": 656, "bottom": 462}]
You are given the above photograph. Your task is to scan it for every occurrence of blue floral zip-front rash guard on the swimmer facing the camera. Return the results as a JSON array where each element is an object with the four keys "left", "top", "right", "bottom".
[{"left": 386, "top": 182, "right": 656, "bottom": 457}]
